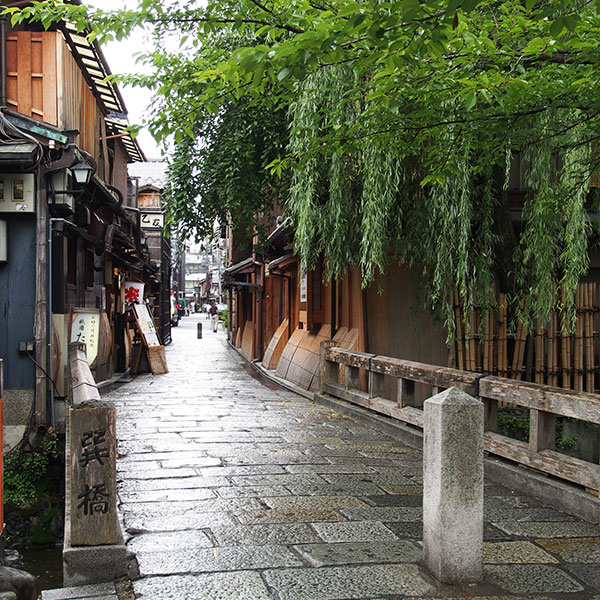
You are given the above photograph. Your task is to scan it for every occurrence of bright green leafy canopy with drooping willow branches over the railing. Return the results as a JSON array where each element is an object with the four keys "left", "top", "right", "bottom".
[{"left": 8, "top": 0, "right": 600, "bottom": 330}]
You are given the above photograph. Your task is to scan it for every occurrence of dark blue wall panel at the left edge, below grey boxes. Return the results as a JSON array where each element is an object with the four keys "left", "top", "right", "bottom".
[{"left": 0, "top": 213, "right": 36, "bottom": 390}]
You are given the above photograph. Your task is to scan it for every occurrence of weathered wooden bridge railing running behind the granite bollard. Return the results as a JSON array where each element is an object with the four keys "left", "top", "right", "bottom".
[{"left": 320, "top": 341, "right": 600, "bottom": 493}]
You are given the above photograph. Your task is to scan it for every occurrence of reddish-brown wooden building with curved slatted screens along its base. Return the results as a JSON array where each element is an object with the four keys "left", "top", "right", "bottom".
[{"left": 225, "top": 218, "right": 378, "bottom": 391}]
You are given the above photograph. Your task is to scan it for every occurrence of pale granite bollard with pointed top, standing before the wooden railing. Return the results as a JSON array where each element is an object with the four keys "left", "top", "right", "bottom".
[{"left": 423, "top": 388, "right": 483, "bottom": 584}]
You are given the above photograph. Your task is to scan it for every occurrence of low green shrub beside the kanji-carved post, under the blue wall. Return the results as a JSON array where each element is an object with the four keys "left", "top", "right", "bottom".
[{"left": 4, "top": 434, "right": 58, "bottom": 504}]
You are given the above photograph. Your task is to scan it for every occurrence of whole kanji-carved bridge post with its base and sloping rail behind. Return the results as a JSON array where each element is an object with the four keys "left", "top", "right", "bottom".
[{"left": 63, "top": 343, "right": 127, "bottom": 587}]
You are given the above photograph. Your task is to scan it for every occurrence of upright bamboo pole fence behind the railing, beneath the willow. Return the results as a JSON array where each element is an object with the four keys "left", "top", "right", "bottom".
[{"left": 454, "top": 283, "right": 600, "bottom": 393}]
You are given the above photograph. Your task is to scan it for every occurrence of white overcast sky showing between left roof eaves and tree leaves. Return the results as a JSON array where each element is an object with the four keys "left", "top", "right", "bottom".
[{"left": 84, "top": 0, "right": 161, "bottom": 159}]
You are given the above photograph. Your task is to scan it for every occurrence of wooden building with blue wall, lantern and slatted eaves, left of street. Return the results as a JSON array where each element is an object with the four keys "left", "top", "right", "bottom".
[{"left": 0, "top": 7, "right": 152, "bottom": 440}]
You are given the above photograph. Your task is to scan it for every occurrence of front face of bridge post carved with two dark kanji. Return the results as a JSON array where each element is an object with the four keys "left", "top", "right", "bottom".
[{"left": 70, "top": 404, "right": 118, "bottom": 546}]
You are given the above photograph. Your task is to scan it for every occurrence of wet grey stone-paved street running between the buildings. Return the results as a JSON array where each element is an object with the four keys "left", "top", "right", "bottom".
[{"left": 98, "top": 315, "right": 600, "bottom": 600}]
